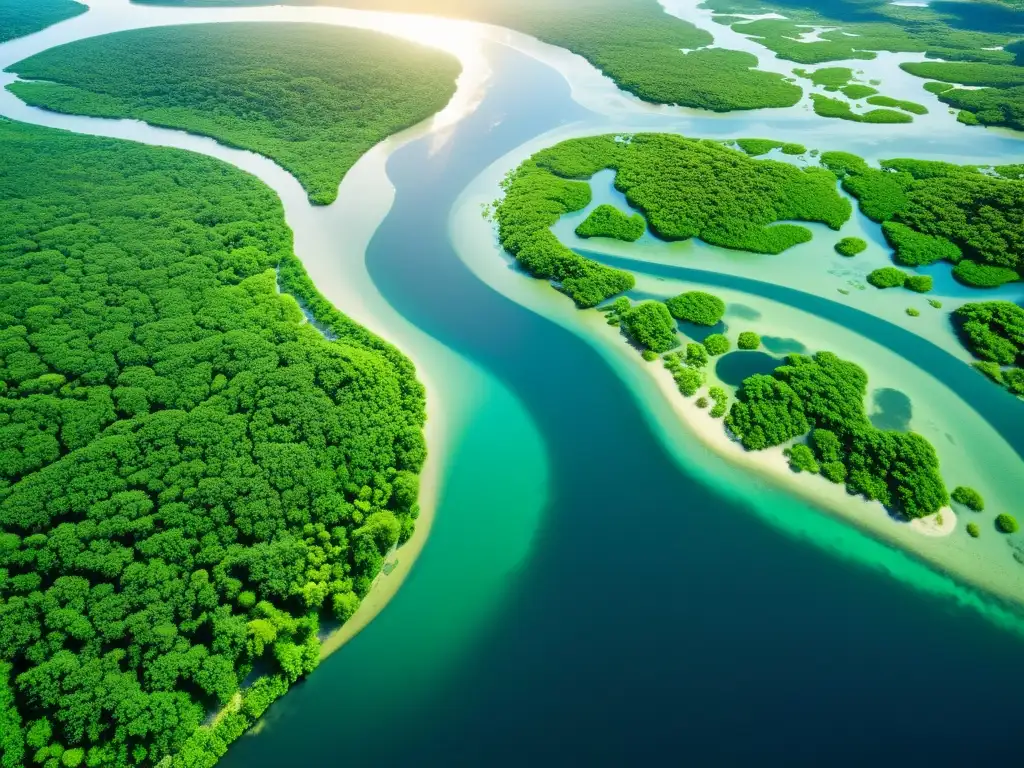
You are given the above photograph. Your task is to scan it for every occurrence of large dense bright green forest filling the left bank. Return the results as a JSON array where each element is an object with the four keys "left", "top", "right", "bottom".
[{"left": 0, "top": 121, "right": 425, "bottom": 766}]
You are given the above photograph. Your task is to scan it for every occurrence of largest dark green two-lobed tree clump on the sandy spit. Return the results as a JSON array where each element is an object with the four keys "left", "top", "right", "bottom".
[{"left": 727, "top": 352, "right": 948, "bottom": 518}]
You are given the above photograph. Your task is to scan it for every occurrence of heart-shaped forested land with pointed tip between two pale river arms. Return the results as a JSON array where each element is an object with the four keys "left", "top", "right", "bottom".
[{"left": 10, "top": 24, "right": 460, "bottom": 204}]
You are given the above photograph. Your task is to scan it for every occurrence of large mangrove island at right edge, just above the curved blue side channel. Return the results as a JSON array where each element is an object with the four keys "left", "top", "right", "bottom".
[{"left": 821, "top": 152, "right": 1024, "bottom": 287}]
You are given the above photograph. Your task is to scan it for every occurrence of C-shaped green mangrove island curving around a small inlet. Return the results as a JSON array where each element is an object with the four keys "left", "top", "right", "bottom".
[{"left": 495, "top": 134, "right": 851, "bottom": 306}]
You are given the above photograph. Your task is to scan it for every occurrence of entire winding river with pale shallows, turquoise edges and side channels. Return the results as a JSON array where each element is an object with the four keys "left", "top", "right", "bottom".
[{"left": 0, "top": 0, "right": 1024, "bottom": 768}]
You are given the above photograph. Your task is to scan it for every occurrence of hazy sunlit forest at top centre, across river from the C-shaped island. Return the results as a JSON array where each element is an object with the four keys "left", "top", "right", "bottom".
[{"left": 125, "top": 0, "right": 803, "bottom": 112}]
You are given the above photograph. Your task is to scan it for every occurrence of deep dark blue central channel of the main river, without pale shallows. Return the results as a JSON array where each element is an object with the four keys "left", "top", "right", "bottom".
[{"left": 224, "top": 43, "right": 1024, "bottom": 768}]
